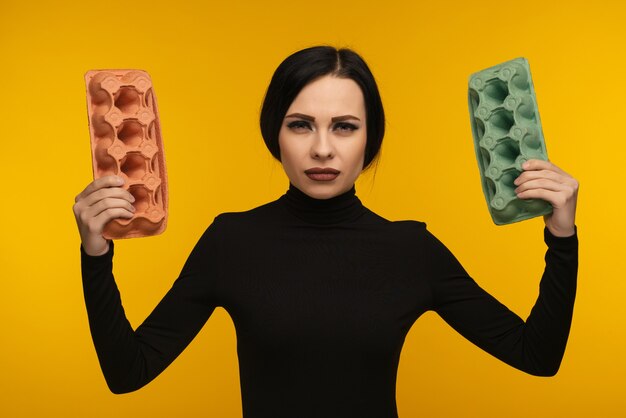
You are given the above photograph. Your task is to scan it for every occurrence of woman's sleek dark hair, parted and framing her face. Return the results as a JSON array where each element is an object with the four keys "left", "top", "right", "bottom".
[{"left": 260, "top": 46, "right": 385, "bottom": 168}]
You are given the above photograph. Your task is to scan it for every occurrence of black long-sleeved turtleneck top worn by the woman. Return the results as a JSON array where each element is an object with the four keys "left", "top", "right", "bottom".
[{"left": 82, "top": 186, "right": 578, "bottom": 418}]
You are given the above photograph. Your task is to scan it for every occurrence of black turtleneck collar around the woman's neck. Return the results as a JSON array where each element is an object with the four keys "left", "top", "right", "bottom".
[{"left": 280, "top": 184, "right": 366, "bottom": 225}]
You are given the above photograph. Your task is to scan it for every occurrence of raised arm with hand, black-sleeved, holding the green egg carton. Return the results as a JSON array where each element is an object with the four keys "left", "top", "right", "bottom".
[{"left": 432, "top": 160, "right": 578, "bottom": 376}]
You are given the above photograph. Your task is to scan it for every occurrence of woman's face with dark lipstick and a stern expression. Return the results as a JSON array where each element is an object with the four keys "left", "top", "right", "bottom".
[{"left": 278, "top": 75, "right": 367, "bottom": 199}]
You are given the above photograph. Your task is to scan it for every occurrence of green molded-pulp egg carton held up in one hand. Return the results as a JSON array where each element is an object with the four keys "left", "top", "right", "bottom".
[{"left": 469, "top": 58, "right": 552, "bottom": 225}]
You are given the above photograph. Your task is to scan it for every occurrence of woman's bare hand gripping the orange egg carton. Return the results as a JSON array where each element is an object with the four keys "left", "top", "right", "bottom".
[{"left": 73, "top": 176, "right": 135, "bottom": 256}]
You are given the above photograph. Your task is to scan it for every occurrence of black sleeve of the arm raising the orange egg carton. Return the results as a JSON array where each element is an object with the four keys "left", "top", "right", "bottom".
[{"left": 81, "top": 227, "right": 216, "bottom": 393}]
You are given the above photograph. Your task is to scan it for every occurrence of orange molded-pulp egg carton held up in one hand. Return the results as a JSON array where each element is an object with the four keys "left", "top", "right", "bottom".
[{"left": 85, "top": 70, "right": 167, "bottom": 239}]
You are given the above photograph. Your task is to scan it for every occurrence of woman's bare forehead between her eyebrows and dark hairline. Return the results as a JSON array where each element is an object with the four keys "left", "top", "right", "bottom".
[{"left": 287, "top": 75, "right": 365, "bottom": 119}]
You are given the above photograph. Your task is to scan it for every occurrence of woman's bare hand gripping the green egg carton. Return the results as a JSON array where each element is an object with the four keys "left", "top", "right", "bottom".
[{"left": 514, "top": 160, "right": 578, "bottom": 237}]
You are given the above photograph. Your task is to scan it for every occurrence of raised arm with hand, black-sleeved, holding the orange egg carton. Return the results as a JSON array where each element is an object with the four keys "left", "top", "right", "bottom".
[{"left": 74, "top": 177, "right": 216, "bottom": 393}]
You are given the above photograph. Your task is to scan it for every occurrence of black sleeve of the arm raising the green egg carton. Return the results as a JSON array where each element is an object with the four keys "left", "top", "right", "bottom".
[{"left": 431, "top": 229, "right": 578, "bottom": 376}]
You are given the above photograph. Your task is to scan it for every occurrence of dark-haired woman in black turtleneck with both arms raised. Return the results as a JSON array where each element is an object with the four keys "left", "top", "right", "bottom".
[{"left": 74, "top": 47, "right": 578, "bottom": 418}]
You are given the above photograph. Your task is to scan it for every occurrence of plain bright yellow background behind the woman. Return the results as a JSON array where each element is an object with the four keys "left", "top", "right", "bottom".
[{"left": 0, "top": 0, "right": 626, "bottom": 418}]
